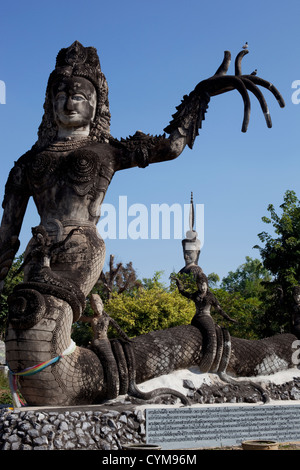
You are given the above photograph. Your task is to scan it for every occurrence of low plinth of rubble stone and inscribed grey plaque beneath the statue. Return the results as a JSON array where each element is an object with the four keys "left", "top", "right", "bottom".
[{"left": 0, "top": 401, "right": 300, "bottom": 451}]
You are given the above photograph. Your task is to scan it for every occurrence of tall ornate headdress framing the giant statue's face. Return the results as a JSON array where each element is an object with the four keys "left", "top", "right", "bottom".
[{"left": 37, "top": 41, "right": 110, "bottom": 147}]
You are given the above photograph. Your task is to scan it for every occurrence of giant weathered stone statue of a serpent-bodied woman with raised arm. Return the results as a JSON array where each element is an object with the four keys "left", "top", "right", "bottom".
[{"left": 0, "top": 41, "right": 295, "bottom": 405}]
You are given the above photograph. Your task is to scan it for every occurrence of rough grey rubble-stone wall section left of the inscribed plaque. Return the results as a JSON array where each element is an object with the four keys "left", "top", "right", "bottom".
[{"left": 0, "top": 407, "right": 146, "bottom": 450}]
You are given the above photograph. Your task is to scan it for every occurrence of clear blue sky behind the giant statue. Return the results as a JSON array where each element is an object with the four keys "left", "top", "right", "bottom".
[{"left": 0, "top": 0, "right": 300, "bottom": 280}]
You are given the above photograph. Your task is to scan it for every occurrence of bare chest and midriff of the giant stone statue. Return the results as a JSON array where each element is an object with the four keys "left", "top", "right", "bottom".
[{"left": 26, "top": 143, "right": 118, "bottom": 226}]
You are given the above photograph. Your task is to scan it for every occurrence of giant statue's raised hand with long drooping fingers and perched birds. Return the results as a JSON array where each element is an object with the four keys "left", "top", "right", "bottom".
[{"left": 194, "top": 49, "right": 285, "bottom": 132}]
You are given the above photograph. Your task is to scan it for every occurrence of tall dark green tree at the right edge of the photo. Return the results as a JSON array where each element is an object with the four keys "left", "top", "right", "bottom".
[{"left": 255, "top": 190, "right": 300, "bottom": 334}]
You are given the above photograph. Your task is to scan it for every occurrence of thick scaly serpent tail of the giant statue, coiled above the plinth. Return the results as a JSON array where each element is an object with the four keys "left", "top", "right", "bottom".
[{"left": 6, "top": 282, "right": 296, "bottom": 406}]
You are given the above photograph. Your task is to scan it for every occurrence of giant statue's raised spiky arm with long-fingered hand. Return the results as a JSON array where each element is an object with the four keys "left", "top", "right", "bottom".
[{"left": 113, "top": 49, "right": 285, "bottom": 167}]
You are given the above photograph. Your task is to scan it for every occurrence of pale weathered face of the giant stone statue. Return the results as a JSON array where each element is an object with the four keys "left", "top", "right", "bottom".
[{"left": 52, "top": 77, "right": 97, "bottom": 129}]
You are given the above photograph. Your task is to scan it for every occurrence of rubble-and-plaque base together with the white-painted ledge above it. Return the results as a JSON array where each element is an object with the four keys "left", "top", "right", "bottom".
[{"left": 0, "top": 369, "right": 300, "bottom": 451}]
